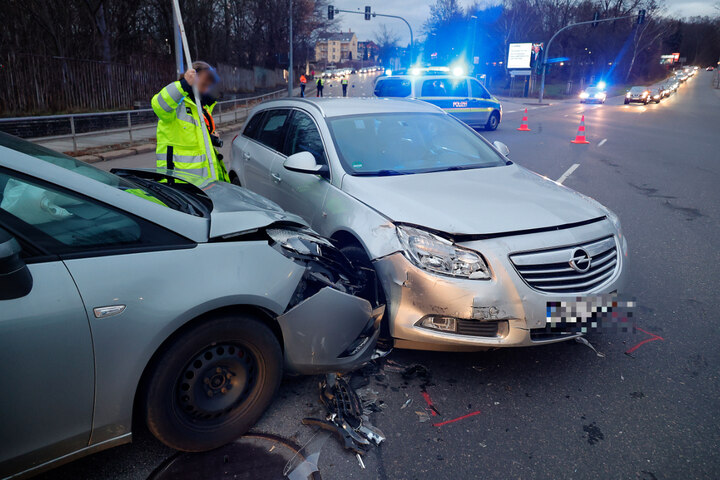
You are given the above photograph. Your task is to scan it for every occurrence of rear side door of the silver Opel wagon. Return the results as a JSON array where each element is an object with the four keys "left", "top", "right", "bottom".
[{"left": 241, "top": 109, "right": 291, "bottom": 199}]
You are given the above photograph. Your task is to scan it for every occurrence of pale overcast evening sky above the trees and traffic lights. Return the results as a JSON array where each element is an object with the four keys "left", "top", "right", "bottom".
[{"left": 330, "top": 0, "right": 717, "bottom": 43}]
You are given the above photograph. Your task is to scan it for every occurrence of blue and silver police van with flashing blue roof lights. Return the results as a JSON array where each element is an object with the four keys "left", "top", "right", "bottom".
[{"left": 375, "top": 69, "right": 502, "bottom": 130}]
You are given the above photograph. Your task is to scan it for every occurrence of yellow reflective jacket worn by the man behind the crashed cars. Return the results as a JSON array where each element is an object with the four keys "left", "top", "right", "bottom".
[{"left": 151, "top": 81, "right": 230, "bottom": 182}]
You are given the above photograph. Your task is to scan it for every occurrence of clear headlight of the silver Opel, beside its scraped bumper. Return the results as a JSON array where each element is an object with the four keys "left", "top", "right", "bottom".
[{"left": 397, "top": 225, "right": 490, "bottom": 279}]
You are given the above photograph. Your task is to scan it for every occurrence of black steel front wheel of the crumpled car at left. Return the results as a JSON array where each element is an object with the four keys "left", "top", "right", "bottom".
[{"left": 144, "top": 314, "right": 283, "bottom": 452}]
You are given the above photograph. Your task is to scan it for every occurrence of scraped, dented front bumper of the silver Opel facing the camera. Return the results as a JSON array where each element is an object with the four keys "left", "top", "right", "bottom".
[{"left": 375, "top": 221, "right": 627, "bottom": 351}]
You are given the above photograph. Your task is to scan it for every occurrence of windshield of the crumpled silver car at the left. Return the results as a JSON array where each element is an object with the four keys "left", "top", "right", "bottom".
[{"left": 0, "top": 133, "right": 193, "bottom": 211}]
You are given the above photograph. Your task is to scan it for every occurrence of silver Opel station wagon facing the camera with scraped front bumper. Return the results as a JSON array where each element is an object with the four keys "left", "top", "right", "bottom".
[{"left": 231, "top": 99, "right": 628, "bottom": 351}]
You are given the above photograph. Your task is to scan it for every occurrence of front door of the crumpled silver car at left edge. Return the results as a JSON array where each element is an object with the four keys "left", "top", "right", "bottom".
[{"left": 0, "top": 168, "right": 95, "bottom": 478}]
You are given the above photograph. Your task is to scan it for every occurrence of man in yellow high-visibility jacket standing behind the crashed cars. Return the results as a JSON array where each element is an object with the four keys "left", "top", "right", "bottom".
[{"left": 151, "top": 62, "right": 230, "bottom": 182}]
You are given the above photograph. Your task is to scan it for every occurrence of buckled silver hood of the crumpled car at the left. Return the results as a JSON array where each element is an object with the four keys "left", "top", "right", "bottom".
[{"left": 119, "top": 168, "right": 308, "bottom": 239}]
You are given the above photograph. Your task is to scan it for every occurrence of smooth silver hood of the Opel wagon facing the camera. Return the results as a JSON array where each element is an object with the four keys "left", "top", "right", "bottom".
[{"left": 342, "top": 164, "right": 606, "bottom": 235}]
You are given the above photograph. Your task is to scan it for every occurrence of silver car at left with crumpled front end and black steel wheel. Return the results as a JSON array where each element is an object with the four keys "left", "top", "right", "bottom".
[{"left": 0, "top": 134, "right": 382, "bottom": 478}]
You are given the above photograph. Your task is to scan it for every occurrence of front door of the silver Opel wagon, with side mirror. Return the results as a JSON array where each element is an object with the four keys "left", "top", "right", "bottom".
[{"left": 270, "top": 110, "right": 330, "bottom": 224}]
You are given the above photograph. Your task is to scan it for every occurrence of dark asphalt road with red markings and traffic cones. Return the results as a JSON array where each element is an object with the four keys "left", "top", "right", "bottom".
[{"left": 42, "top": 72, "right": 720, "bottom": 480}]
